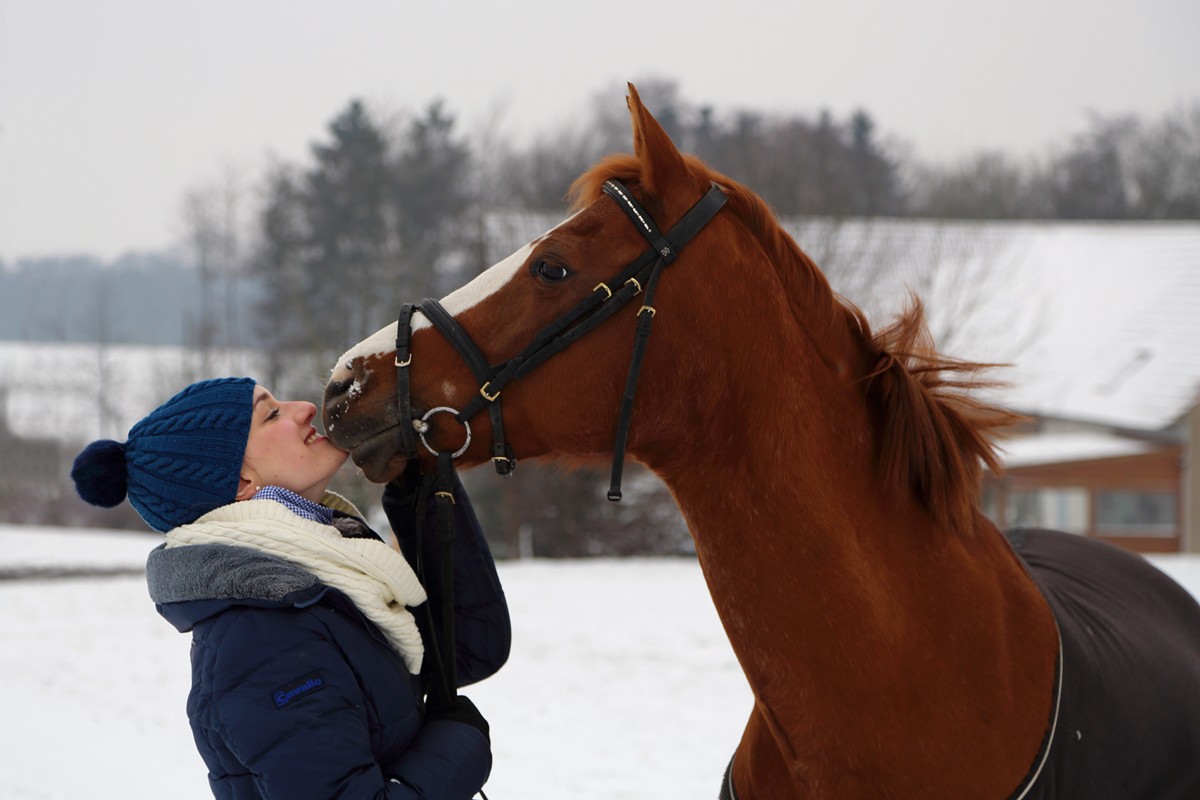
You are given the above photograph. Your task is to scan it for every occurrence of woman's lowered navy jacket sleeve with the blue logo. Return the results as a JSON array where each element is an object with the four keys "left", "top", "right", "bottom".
[{"left": 199, "top": 606, "right": 491, "bottom": 800}]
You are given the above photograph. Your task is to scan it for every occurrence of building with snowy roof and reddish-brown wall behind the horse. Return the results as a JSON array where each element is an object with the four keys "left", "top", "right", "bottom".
[{"left": 790, "top": 221, "right": 1200, "bottom": 552}]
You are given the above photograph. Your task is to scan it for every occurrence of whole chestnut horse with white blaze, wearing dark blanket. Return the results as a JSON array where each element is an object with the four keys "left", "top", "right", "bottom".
[{"left": 324, "top": 85, "right": 1200, "bottom": 800}]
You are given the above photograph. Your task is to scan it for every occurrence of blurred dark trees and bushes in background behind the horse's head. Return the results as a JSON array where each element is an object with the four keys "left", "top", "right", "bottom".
[{"left": 11, "top": 80, "right": 1200, "bottom": 555}]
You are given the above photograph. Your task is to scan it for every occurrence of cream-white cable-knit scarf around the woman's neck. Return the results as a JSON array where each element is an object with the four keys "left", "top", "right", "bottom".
[{"left": 167, "top": 494, "right": 426, "bottom": 675}]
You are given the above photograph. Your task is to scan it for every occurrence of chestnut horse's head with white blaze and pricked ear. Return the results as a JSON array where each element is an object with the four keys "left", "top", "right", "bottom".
[{"left": 324, "top": 86, "right": 722, "bottom": 481}]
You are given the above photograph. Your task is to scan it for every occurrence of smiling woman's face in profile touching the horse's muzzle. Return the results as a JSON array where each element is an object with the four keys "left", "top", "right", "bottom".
[{"left": 238, "top": 386, "right": 348, "bottom": 503}]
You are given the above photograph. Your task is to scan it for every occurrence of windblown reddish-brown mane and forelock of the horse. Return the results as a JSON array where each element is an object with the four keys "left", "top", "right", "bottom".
[{"left": 570, "top": 155, "right": 1021, "bottom": 531}]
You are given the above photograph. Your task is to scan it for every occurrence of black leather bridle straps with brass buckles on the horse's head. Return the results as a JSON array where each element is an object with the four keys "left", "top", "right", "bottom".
[{"left": 396, "top": 180, "right": 726, "bottom": 501}]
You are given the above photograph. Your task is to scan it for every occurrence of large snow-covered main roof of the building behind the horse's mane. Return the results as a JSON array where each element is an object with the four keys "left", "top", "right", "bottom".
[{"left": 786, "top": 221, "right": 1200, "bottom": 431}]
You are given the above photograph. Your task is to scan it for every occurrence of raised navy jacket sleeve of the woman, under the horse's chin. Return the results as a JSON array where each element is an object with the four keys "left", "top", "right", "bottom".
[{"left": 383, "top": 467, "right": 512, "bottom": 686}]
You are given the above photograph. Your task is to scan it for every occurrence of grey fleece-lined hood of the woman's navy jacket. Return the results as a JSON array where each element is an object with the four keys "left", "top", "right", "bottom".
[{"left": 146, "top": 545, "right": 328, "bottom": 632}]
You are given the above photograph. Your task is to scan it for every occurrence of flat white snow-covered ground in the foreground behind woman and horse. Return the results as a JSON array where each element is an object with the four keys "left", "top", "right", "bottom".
[{"left": 0, "top": 527, "right": 1200, "bottom": 800}]
